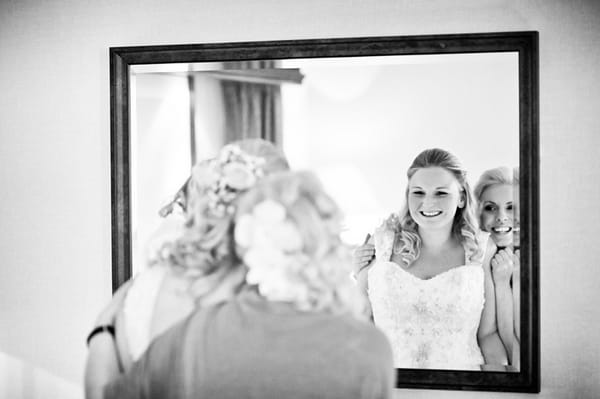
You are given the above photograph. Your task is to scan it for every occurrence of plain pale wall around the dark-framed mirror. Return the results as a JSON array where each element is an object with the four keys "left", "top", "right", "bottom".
[{"left": 0, "top": 0, "right": 600, "bottom": 398}]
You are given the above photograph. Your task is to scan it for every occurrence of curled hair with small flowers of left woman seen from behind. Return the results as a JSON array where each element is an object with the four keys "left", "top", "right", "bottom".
[{"left": 152, "top": 139, "right": 289, "bottom": 298}]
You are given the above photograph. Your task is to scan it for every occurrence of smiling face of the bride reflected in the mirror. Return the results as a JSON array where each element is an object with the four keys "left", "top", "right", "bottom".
[{"left": 408, "top": 167, "right": 465, "bottom": 229}]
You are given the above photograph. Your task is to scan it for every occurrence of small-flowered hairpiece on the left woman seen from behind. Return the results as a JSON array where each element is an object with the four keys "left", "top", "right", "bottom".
[{"left": 191, "top": 144, "right": 265, "bottom": 217}]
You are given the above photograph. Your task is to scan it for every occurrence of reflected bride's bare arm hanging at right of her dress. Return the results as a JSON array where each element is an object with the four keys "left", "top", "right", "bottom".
[{"left": 477, "top": 244, "right": 508, "bottom": 366}]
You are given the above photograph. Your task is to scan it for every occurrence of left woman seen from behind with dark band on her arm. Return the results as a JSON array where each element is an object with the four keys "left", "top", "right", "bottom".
[{"left": 85, "top": 139, "right": 288, "bottom": 398}]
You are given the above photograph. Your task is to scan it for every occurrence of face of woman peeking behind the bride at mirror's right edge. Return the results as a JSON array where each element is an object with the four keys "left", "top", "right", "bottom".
[{"left": 480, "top": 184, "right": 514, "bottom": 247}]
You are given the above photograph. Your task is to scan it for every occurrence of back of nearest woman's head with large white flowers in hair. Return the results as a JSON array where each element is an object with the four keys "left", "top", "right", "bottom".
[{"left": 235, "top": 172, "right": 365, "bottom": 315}]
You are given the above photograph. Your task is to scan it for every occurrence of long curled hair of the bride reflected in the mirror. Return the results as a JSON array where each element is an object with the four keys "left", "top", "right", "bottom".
[{"left": 388, "top": 148, "right": 481, "bottom": 266}]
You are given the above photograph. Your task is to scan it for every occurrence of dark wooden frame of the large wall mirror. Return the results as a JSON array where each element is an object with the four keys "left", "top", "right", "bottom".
[{"left": 110, "top": 31, "right": 540, "bottom": 392}]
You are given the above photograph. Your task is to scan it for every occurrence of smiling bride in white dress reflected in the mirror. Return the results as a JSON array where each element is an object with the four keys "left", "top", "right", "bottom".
[{"left": 354, "top": 149, "right": 507, "bottom": 370}]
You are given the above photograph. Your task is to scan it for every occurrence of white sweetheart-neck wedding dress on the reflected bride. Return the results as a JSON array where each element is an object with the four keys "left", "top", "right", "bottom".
[{"left": 368, "top": 232, "right": 485, "bottom": 370}]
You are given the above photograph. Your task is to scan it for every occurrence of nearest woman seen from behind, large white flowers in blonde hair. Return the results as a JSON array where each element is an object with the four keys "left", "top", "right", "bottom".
[{"left": 106, "top": 172, "right": 394, "bottom": 398}]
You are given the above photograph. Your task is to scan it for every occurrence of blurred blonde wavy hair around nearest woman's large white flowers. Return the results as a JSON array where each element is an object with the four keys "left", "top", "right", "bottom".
[{"left": 236, "top": 172, "right": 367, "bottom": 317}]
